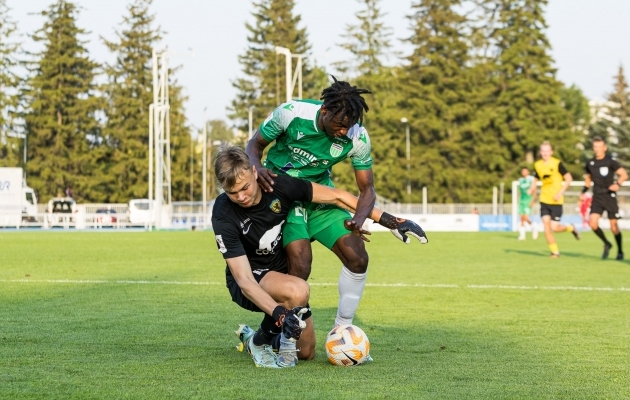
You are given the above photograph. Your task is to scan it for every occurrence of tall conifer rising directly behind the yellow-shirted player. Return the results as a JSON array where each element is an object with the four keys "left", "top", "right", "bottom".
[{"left": 490, "top": 0, "right": 582, "bottom": 176}]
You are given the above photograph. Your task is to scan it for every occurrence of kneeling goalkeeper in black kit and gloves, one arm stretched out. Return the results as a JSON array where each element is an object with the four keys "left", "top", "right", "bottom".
[{"left": 212, "top": 146, "right": 427, "bottom": 368}]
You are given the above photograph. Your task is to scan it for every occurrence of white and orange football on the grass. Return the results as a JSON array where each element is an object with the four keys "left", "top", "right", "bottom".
[{"left": 326, "top": 325, "right": 370, "bottom": 367}]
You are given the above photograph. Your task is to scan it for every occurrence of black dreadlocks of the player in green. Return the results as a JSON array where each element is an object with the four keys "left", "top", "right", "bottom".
[{"left": 320, "top": 75, "right": 372, "bottom": 126}]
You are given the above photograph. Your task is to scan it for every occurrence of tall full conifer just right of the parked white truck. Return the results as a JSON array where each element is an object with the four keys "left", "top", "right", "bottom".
[{"left": 24, "top": 0, "right": 101, "bottom": 202}]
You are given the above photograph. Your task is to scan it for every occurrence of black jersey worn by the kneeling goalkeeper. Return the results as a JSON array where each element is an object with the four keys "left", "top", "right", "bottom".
[{"left": 212, "top": 175, "right": 313, "bottom": 275}]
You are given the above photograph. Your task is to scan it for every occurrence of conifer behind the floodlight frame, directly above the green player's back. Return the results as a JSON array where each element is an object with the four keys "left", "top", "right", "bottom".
[{"left": 229, "top": 0, "right": 328, "bottom": 131}]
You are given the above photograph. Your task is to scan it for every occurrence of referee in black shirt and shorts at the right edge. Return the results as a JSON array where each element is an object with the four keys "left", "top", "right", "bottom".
[{"left": 580, "top": 136, "right": 628, "bottom": 260}]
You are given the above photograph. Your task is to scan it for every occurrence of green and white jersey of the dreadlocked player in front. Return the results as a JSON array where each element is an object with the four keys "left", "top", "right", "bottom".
[{"left": 259, "top": 100, "right": 372, "bottom": 186}]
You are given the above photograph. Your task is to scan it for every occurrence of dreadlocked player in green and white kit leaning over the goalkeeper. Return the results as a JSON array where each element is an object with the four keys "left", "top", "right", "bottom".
[{"left": 246, "top": 77, "right": 426, "bottom": 325}]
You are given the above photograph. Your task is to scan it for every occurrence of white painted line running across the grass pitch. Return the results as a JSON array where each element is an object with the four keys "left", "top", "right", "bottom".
[{"left": 0, "top": 279, "right": 630, "bottom": 292}]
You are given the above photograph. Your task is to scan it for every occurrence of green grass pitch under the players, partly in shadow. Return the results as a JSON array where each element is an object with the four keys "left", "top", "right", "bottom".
[{"left": 0, "top": 232, "right": 630, "bottom": 399}]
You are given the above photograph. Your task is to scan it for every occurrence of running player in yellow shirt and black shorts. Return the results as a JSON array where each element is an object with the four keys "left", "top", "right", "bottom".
[{"left": 529, "top": 141, "right": 580, "bottom": 258}]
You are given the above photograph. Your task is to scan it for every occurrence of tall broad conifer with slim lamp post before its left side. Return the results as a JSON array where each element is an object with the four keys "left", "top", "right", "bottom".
[{"left": 394, "top": 0, "right": 500, "bottom": 202}]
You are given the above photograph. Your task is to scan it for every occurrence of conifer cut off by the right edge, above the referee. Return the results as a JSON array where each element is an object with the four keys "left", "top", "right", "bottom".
[{"left": 585, "top": 66, "right": 630, "bottom": 169}]
